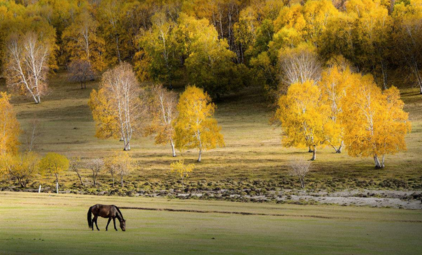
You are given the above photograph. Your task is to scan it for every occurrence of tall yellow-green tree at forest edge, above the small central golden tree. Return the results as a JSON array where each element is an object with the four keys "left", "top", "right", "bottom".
[{"left": 178, "top": 14, "right": 247, "bottom": 97}]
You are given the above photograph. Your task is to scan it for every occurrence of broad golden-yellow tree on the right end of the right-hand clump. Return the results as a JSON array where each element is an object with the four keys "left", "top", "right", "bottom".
[{"left": 342, "top": 75, "right": 411, "bottom": 168}]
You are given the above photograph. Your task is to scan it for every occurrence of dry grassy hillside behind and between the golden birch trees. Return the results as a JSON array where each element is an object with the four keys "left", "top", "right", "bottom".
[{"left": 1, "top": 73, "right": 422, "bottom": 188}]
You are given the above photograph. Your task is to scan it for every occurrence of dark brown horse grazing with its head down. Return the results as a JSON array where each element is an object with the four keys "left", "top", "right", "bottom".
[{"left": 88, "top": 204, "right": 126, "bottom": 231}]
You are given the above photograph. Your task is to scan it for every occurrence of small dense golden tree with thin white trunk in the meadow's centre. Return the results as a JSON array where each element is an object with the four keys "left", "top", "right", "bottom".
[{"left": 174, "top": 86, "right": 224, "bottom": 162}]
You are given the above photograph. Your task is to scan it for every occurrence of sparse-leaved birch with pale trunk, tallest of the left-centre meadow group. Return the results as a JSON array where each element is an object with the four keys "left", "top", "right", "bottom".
[{"left": 88, "top": 63, "right": 145, "bottom": 151}]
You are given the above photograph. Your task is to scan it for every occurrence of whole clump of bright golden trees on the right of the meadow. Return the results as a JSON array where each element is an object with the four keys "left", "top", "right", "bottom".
[{"left": 276, "top": 62, "right": 411, "bottom": 168}]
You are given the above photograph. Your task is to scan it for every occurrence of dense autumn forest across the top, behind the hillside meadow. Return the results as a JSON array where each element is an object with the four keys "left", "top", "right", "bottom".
[{"left": 0, "top": 0, "right": 422, "bottom": 99}]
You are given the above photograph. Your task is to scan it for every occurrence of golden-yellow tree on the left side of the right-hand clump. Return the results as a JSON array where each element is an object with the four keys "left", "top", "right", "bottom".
[{"left": 276, "top": 80, "right": 328, "bottom": 160}]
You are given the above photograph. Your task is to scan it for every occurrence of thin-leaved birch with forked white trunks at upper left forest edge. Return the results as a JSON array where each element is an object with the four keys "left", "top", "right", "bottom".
[{"left": 5, "top": 32, "right": 50, "bottom": 104}]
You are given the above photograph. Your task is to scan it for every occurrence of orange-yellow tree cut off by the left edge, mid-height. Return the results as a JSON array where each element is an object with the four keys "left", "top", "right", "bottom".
[{"left": 0, "top": 92, "right": 21, "bottom": 156}]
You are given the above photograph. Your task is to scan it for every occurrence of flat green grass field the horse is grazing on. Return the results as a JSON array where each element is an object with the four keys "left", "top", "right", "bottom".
[{"left": 0, "top": 192, "right": 422, "bottom": 254}]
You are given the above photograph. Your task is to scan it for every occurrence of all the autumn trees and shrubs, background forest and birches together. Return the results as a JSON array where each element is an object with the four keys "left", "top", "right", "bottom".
[{"left": 0, "top": 0, "right": 422, "bottom": 192}]
